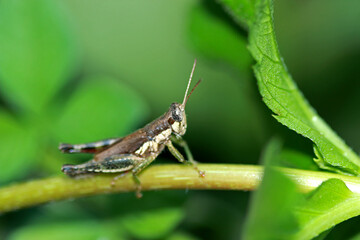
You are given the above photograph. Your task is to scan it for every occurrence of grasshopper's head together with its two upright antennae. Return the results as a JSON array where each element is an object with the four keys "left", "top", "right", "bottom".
[{"left": 169, "top": 59, "right": 201, "bottom": 135}]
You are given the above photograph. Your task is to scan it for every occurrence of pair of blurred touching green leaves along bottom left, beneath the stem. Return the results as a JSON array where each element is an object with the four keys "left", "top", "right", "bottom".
[{"left": 9, "top": 209, "right": 183, "bottom": 240}]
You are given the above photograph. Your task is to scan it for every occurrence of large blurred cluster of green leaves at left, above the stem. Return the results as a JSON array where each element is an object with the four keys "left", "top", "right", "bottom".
[{"left": 0, "top": 0, "right": 147, "bottom": 183}]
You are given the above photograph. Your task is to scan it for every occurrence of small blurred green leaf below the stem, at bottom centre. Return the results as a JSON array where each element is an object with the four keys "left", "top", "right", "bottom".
[{"left": 122, "top": 208, "right": 184, "bottom": 239}]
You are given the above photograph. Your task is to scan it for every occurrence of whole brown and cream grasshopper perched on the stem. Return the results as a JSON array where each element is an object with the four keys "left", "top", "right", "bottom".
[{"left": 59, "top": 59, "right": 205, "bottom": 198}]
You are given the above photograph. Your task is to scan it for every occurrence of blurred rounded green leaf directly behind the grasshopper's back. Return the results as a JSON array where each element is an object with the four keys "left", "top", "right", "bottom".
[{"left": 55, "top": 76, "right": 148, "bottom": 143}]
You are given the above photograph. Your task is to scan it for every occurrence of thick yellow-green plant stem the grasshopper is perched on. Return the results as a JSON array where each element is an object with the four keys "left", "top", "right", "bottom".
[{"left": 0, "top": 164, "right": 360, "bottom": 212}]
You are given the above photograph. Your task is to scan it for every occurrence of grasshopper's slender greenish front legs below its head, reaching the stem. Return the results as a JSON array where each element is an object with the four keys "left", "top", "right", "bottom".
[{"left": 166, "top": 136, "right": 205, "bottom": 177}]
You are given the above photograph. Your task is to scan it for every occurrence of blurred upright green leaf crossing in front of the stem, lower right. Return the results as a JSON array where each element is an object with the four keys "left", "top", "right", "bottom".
[{"left": 242, "top": 139, "right": 298, "bottom": 240}]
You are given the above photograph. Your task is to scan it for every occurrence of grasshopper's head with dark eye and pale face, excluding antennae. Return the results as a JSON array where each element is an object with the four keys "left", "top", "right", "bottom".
[{"left": 168, "top": 103, "right": 187, "bottom": 136}]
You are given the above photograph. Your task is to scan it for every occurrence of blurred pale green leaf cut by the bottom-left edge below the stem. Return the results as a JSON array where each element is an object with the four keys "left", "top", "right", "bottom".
[{"left": 8, "top": 221, "right": 123, "bottom": 240}]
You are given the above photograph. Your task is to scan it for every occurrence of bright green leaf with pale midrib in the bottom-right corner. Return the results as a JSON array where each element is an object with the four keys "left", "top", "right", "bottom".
[{"left": 294, "top": 179, "right": 360, "bottom": 239}]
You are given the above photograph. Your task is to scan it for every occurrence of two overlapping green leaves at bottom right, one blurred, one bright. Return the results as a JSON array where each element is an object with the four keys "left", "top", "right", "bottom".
[{"left": 243, "top": 139, "right": 360, "bottom": 239}]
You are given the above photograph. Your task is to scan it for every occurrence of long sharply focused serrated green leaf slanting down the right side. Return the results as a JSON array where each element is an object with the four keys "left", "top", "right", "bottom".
[{"left": 221, "top": 0, "right": 360, "bottom": 175}]
